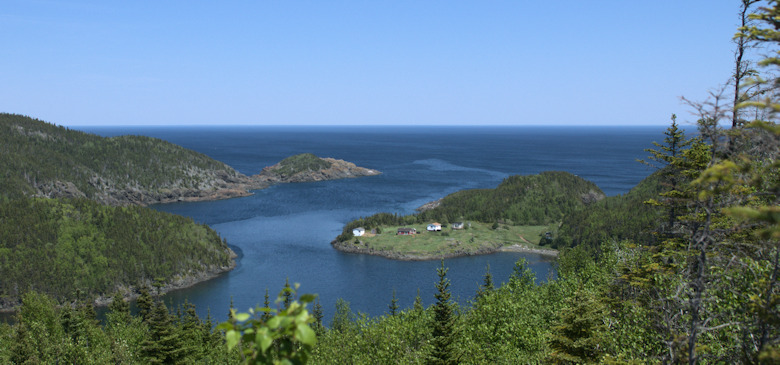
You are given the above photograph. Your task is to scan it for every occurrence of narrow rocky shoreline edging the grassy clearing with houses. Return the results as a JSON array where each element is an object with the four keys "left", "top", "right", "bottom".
[{"left": 330, "top": 240, "right": 558, "bottom": 261}]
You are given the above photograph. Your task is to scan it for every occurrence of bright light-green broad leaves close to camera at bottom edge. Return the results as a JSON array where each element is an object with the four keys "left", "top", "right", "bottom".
[{"left": 217, "top": 284, "right": 317, "bottom": 364}]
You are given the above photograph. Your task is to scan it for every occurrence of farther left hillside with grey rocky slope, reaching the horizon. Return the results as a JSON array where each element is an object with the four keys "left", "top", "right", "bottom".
[{"left": 0, "top": 113, "right": 254, "bottom": 205}]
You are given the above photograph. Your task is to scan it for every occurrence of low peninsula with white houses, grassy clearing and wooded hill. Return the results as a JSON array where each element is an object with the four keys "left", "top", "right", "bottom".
[{"left": 331, "top": 171, "right": 605, "bottom": 260}]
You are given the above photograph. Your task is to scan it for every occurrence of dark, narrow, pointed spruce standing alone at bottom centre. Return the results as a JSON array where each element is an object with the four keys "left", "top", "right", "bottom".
[{"left": 429, "top": 260, "right": 457, "bottom": 364}]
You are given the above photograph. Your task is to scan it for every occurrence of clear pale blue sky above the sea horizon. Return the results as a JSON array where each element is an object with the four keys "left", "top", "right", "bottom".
[{"left": 0, "top": 0, "right": 756, "bottom": 126}]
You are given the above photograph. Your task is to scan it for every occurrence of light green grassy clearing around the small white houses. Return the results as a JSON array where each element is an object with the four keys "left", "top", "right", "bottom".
[{"left": 353, "top": 222, "right": 549, "bottom": 255}]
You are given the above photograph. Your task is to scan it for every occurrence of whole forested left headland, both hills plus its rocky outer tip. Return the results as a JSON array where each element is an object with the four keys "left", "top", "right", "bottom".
[{"left": 0, "top": 113, "right": 379, "bottom": 311}]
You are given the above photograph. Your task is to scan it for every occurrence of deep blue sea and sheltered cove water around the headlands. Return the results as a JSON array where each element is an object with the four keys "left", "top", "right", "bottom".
[{"left": 80, "top": 126, "right": 664, "bottom": 320}]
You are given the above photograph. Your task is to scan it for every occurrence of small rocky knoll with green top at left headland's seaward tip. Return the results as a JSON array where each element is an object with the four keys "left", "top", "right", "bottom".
[{"left": 252, "top": 157, "right": 381, "bottom": 184}]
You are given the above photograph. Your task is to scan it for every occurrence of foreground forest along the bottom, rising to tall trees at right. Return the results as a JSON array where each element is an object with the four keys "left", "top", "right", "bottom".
[{"left": 0, "top": 0, "right": 780, "bottom": 364}]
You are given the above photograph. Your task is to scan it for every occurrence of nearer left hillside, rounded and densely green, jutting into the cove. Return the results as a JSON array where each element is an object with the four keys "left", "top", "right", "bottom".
[{"left": 0, "top": 198, "right": 234, "bottom": 309}]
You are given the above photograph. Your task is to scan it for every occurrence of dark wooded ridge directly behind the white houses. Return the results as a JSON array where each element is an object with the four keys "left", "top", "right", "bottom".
[{"left": 337, "top": 171, "right": 604, "bottom": 242}]
